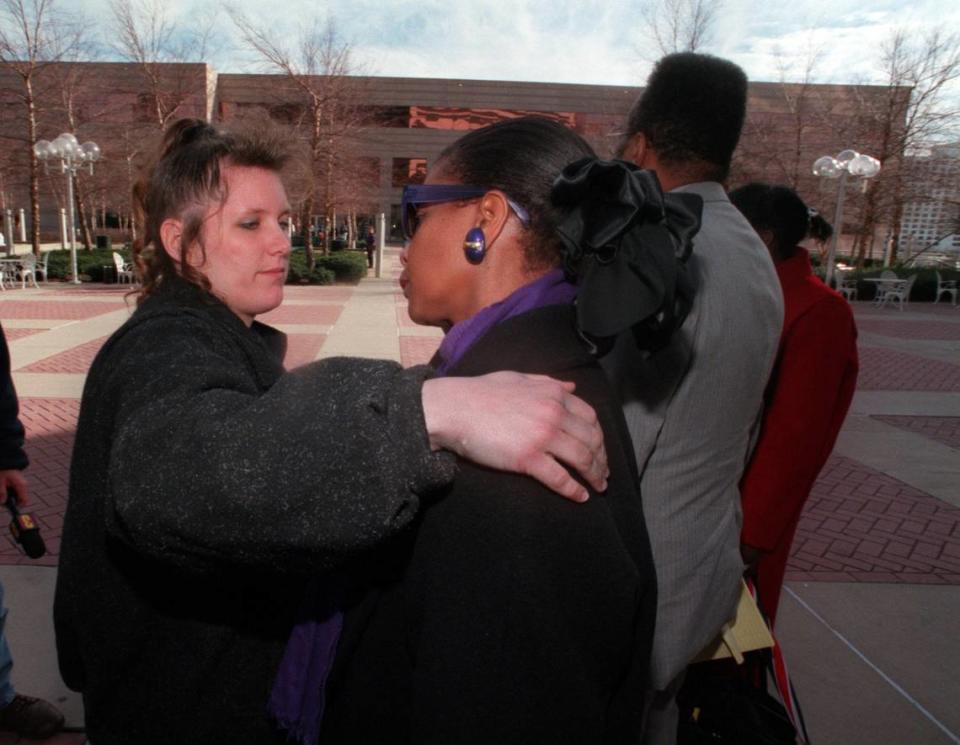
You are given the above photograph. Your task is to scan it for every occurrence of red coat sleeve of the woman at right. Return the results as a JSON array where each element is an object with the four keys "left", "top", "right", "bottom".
[{"left": 741, "top": 296, "right": 858, "bottom": 552}]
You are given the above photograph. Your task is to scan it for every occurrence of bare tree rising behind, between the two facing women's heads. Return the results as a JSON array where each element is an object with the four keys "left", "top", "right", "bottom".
[{"left": 228, "top": 8, "right": 363, "bottom": 268}]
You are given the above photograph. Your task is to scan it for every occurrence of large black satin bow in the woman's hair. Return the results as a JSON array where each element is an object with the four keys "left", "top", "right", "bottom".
[{"left": 551, "top": 158, "right": 703, "bottom": 355}]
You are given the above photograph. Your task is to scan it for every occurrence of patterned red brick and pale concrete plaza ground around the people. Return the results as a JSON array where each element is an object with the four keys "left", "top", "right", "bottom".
[{"left": 0, "top": 249, "right": 960, "bottom": 745}]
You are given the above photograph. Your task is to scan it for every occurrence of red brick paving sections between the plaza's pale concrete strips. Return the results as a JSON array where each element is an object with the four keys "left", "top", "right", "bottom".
[{"left": 0, "top": 282, "right": 960, "bottom": 584}]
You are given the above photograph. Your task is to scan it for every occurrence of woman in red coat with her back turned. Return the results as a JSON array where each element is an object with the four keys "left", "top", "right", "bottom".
[{"left": 730, "top": 184, "right": 859, "bottom": 624}]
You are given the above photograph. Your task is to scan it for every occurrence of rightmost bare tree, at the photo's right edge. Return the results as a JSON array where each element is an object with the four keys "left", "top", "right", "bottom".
[{"left": 856, "top": 28, "right": 960, "bottom": 262}]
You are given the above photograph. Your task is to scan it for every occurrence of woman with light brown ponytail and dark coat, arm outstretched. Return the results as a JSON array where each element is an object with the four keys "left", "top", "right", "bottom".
[{"left": 54, "top": 120, "right": 606, "bottom": 745}]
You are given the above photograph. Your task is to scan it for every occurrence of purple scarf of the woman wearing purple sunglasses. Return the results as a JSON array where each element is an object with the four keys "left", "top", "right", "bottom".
[{"left": 267, "top": 269, "right": 577, "bottom": 745}]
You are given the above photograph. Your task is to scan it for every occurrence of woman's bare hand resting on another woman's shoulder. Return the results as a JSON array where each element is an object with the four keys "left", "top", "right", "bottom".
[{"left": 423, "top": 372, "right": 609, "bottom": 502}]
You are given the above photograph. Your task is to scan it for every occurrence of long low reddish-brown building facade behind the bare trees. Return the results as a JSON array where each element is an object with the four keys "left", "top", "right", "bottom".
[{"left": 0, "top": 63, "right": 889, "bottom": 247}]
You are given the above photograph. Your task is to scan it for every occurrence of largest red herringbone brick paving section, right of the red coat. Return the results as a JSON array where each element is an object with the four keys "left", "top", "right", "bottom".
[{"left": 787, "top": 456, "right": 960, "bottom": 584}]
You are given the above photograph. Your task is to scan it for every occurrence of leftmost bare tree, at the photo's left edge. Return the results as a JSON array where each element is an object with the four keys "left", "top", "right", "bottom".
[{"left": 0, "top": 0, "right": 86, "bottom": 256}]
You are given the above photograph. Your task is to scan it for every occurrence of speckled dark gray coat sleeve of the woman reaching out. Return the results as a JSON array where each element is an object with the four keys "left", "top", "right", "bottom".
[{"left": 97, "top": 315, "right": 455, "bottom": 571}]
